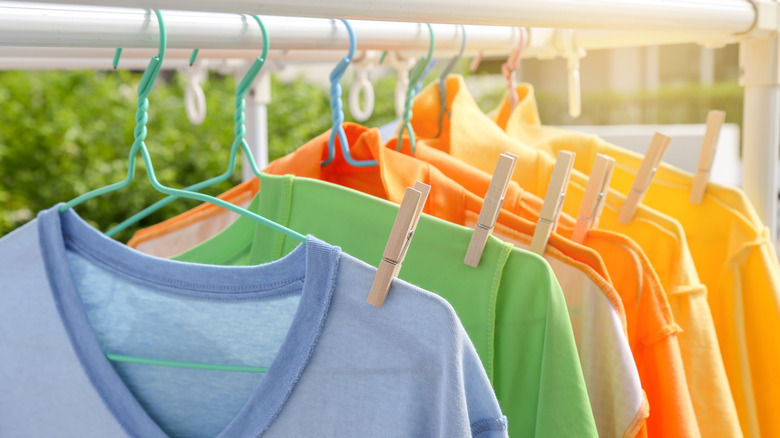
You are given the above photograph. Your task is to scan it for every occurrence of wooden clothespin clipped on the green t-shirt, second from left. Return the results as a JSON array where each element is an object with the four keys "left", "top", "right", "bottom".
[{"left": 463, "top": 152, "right": 517, "bottom": 268}]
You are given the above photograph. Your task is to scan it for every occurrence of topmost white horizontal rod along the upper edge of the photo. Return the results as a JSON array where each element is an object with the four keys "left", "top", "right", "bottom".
[{"left": 6, "top": 0, "right": 755, "bottom": 34}]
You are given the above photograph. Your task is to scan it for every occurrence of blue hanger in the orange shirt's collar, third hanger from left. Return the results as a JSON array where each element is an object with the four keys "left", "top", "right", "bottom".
[{"left": 320, "top": 19, "right": 379, "bottom": 167}]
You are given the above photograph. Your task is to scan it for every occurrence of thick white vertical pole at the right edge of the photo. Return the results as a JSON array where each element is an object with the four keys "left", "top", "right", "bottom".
[{"left": 739, "top": 35, "right": 780, "bottom": 242}]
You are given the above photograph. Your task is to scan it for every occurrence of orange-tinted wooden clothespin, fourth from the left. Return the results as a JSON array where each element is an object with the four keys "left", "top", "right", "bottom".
[{"left": 571, "top": 154, "right": 615, "bottom": 243}]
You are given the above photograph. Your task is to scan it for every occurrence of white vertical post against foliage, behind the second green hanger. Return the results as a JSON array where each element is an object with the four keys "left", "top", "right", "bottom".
[{"left": 242, "top": 70, "right": 271, "bottom": 181}]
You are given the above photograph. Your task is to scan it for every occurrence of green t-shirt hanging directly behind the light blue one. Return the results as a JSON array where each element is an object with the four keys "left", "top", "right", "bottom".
[{"left": 176, "top": 174, "right": 597, "bottom": 437}]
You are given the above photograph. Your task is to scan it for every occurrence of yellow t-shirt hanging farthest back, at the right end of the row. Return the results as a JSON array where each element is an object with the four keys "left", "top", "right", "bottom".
[{"left": 498, "top": 84, "right": 780, "bottom": 437}]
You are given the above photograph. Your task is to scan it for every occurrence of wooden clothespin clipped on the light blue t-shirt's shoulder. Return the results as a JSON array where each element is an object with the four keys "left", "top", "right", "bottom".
[{"left": 366, "top": 182, "right": 431, "bottom": 307}]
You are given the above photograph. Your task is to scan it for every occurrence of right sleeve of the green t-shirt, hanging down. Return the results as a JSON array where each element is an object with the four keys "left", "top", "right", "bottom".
[{"left": 494, "top": 249, "right": 598, "bottom": 438}]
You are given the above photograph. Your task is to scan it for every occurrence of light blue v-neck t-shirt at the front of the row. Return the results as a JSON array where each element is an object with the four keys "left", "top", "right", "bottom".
[{"left": 0, "top": 206, "right": 507, "bottom": 438}]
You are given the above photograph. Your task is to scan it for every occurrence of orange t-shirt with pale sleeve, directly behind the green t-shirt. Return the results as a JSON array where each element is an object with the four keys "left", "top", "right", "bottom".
[{"left": 265, "top": 124, "right": 645, "bottom": 436}]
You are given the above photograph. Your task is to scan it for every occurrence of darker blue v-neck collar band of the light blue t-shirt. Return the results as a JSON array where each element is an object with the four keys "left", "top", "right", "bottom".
[{"left": 38, "top": 205, "right": 340, "bottom": 438}]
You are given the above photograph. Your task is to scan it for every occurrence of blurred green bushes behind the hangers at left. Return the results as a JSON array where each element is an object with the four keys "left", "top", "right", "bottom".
[{"left": 0, "top": 71, "right": 384, "bottom": 240}]
